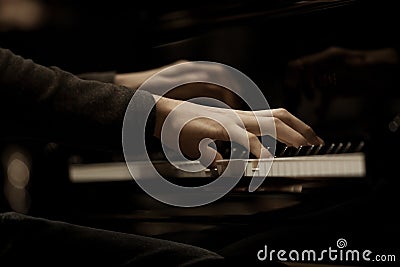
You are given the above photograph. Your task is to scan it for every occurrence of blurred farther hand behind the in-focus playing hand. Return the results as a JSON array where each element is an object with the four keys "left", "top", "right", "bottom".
[{"left": 115, "top": 60, "right": 242, "bottom": 109}]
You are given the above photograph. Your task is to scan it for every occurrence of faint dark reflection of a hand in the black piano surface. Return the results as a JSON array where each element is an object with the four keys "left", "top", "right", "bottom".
[{"left": 285, "top": 47, "right": 399, "bottom": 98}]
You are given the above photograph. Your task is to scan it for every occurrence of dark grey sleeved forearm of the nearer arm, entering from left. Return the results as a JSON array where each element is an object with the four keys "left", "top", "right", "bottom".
[{"left": 0, "top": 48, "right": 154, "bottom": 151}]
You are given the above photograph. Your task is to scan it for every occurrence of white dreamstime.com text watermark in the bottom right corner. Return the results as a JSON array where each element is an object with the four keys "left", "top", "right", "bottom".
[{"left": 257, "top": 238, "right": 397, "bottom": 263}]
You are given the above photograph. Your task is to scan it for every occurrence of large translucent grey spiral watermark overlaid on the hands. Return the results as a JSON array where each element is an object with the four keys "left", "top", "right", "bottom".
[{"left": 122, "top": 61, "right": 276, "bottom": 207}]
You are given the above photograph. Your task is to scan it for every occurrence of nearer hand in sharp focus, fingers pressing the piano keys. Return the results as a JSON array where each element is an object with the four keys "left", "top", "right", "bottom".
[{"left": 154, "top": 96, "right": 323, "bottom": 168}]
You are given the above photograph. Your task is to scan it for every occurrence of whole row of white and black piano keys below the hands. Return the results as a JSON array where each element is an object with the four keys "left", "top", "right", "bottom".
[{"left": 69, "top": 142, "right": 366, "bottom": 182}]
